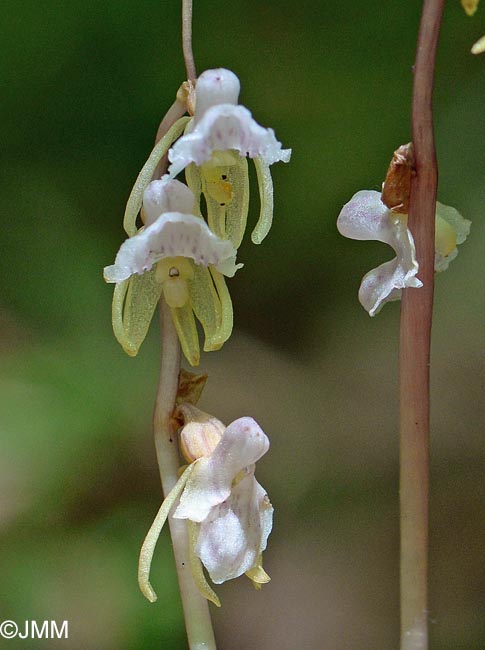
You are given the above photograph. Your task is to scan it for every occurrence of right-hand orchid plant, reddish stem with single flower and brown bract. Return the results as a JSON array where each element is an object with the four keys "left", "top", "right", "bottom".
[{"left": 337, "top": 0, "right": 474, "bottom": 636}]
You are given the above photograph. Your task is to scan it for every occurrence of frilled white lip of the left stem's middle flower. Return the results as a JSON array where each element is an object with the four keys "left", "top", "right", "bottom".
[{"left": 104, "top": 212, "right": 241, "bottom": 282}]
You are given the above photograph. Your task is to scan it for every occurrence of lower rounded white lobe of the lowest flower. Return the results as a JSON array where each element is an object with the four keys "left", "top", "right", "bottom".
[{"left": 195, "top": 474, "right": 273, "bottom": 584}]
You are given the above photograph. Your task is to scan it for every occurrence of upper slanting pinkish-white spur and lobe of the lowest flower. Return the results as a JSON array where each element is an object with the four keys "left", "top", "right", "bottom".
[{"left": 174, "top": 417, "right": 269, "bottom": 520}]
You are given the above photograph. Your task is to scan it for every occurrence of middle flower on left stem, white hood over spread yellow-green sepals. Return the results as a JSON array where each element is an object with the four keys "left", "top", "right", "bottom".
[{"left": 104, "top": 180, "right": 242, "bottom": 365}]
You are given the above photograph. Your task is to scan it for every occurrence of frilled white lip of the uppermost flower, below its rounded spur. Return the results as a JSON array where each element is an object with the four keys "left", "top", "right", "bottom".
[{"left": 168, "top": 104, "right": 291, "bottom": 178}]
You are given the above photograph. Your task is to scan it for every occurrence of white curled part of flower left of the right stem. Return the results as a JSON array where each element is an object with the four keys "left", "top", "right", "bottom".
[{"left": 337, "top": 190, "right": 423, "bottom": 316}]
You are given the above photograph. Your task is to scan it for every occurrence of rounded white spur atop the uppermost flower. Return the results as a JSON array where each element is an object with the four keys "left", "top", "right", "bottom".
[{"left": 194, "top": 68, "right": 241, "bottom": 123}]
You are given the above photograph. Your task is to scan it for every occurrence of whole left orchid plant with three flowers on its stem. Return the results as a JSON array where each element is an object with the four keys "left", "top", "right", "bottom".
[{"left": 104, "top": 2, "right": 291, "bottom": 650}]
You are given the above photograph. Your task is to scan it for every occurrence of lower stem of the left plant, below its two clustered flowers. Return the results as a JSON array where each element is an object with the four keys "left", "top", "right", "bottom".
[{"left": 153, "top": 297, "right": 216, "bottom": 650}]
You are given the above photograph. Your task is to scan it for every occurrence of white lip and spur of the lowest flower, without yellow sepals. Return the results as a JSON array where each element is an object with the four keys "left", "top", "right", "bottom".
[{"left": 173, "top": 417, "right": 273, "bottom": 584}]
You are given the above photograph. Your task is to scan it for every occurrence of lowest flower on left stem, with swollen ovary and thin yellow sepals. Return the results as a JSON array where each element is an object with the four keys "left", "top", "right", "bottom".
[{"left": 138, "top": 404, "right": 273, "bottom": 605}]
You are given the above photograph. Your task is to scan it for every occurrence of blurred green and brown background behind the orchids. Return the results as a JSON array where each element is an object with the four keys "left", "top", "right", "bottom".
[{"left": 0, "top": 0, "right": 485, "bottom": 650}]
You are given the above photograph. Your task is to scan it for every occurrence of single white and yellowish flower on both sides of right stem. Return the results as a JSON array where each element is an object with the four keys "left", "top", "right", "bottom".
[{"left": 337, "top": 190, "right": 471, "bottom": 316}]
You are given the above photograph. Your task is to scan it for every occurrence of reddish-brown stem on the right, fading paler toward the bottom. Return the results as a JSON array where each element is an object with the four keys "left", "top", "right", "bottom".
[{"left": 400, "top": 0, "right": 444, "bottom": 650}]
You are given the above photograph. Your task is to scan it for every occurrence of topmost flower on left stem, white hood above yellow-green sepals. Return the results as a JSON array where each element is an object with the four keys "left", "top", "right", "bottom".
[{"left": 124, "top": 68, "right": 291, "bottom": 248}]
